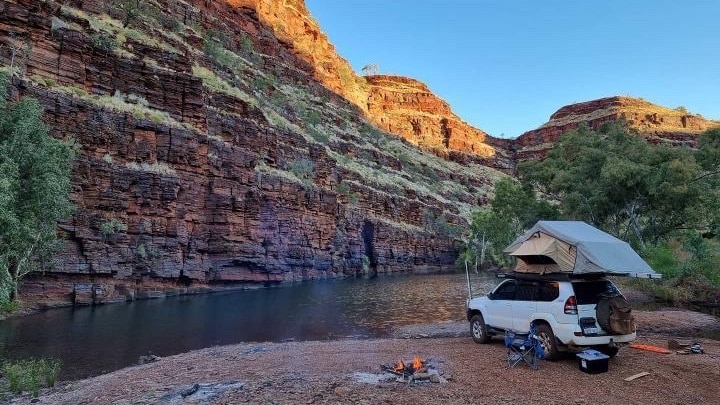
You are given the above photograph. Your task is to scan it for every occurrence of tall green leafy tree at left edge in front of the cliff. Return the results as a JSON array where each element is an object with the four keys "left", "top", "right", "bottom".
[{"left": 0, "top": 72, "right": 74, "bottom": 303}]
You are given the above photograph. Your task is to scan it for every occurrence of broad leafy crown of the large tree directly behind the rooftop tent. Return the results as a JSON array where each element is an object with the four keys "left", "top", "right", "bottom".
[{"left": 519, "top": 124, "right": 709, "bottom": 248}]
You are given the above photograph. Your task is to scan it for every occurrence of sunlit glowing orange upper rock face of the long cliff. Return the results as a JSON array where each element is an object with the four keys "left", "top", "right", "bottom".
[{"left": 242, "top": 0, "right": 512, "bottom": 166}]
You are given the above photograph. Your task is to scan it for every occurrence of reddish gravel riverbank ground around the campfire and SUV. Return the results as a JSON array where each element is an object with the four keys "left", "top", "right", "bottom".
[{"left": 11, "top": 310, "right": 720, "bottom": 404}]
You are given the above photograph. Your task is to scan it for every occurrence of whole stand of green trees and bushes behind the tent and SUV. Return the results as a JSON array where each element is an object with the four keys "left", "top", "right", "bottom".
[{"left": 465, "top": 124, "right": 720, "bottom": 302}]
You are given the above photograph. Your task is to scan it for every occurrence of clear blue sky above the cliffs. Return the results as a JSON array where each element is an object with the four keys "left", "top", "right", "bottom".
[{"left": 306, "top": 0, "right": 720, "bottom": 137}]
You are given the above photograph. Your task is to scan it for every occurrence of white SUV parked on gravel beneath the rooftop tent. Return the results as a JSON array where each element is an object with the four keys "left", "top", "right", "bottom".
[{"left": 467, "top": 275, "right": 635, "bottom": 360}]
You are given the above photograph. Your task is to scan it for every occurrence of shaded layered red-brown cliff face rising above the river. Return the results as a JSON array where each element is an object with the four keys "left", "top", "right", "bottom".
[{"left": 0, "top": 0, "right": 504, "bottom": 305}]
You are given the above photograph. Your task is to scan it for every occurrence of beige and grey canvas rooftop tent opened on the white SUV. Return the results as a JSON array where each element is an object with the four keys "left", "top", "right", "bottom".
[{"left": 505, "top": 221, "right": 660, "bottom": 278}]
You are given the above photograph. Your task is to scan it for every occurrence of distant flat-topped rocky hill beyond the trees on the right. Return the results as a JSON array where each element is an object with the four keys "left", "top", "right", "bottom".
[{"left": 514, "top": 96, "right": 720, "bottom": 160}]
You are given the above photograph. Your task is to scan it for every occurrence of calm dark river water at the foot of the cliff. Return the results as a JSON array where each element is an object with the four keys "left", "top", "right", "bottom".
[{"left": 0, "top": 274, "right": 497, "bottom": 379}]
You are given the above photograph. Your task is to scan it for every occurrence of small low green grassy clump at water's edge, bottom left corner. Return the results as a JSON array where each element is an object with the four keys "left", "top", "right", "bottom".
[{"left": 2, "top": 359, "right": 60, "bottom": 398}]
